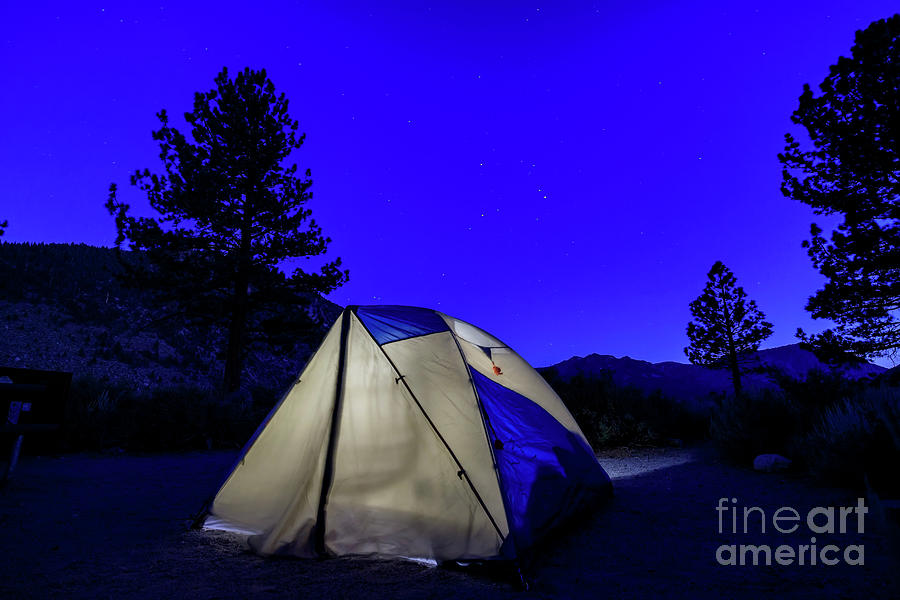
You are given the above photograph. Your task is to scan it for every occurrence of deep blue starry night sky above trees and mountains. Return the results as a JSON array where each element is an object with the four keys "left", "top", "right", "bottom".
[{"left": 0, "top": 1, "right": 897, "bottom": 365}]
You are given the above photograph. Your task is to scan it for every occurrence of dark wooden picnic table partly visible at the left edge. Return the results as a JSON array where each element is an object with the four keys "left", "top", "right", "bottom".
[{"left": 0, "top": 367, "right": 72, "bottom": 487}]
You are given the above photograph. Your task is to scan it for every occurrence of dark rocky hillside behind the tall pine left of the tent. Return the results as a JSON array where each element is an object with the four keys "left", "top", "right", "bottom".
[{"left": 0, "top": 243, "right": 340, "bottom": 390}]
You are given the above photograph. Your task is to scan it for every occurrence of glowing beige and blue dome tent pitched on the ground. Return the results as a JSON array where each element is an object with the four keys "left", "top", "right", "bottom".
[{"left": 203, "top": 306, "right": 612, "bottom": 562}]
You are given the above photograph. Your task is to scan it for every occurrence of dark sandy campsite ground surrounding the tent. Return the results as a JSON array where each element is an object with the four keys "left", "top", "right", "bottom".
[{"left": 0, "top": 448, "right": 900, "bottom": 599}]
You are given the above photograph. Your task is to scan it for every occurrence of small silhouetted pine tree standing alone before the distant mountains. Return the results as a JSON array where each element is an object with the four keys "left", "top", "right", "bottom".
[{"left": 684, "top": 261, "right": 772, "bottom": 396}]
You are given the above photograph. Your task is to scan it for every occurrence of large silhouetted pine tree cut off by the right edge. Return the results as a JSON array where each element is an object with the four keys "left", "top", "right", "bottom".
[{"left": 778, "top": 14, "right": 900, "bottom": 356}]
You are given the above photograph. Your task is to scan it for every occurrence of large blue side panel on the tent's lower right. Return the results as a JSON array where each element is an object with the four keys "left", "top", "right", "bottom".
[{"left": 469, "top": 367, "right": 612, "bottom": 558}]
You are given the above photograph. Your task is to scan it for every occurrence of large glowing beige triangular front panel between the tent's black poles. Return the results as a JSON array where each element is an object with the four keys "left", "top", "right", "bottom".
[{"left": 325, "top": 316, "right": 502, "bottom": 560}]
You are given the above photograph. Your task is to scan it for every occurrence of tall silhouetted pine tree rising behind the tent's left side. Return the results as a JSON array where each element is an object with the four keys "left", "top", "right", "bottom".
[{"left": 106, "top": 69, "right": 349, "bottom": 392}]
